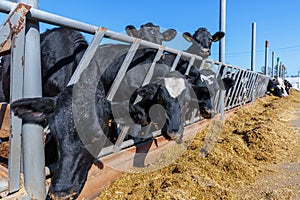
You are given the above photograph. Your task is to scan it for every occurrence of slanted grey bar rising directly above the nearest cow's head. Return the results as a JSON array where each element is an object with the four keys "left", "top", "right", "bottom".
[{"left": 68, "top": 27, "right": 107, "bottom": 85}]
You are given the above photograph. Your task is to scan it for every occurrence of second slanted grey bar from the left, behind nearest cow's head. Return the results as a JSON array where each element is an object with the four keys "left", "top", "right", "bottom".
[{"left": 107, "top": 39, "right": 141, "bottom": 101}]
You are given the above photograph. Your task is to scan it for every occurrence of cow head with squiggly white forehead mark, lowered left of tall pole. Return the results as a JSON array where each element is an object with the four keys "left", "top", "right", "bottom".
[{"left": 192, "top": 69, "right": 234, "bottom": 119}]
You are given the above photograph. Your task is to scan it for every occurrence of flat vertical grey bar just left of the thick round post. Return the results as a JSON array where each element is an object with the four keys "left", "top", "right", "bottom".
[{"left": 8, "top": 17, "right": 26, "bottom": 193}]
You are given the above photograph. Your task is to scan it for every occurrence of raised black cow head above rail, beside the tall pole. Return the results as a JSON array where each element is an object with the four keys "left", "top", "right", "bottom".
[{"left": 182, "top": 28, "right": 225, "bottom": 59}]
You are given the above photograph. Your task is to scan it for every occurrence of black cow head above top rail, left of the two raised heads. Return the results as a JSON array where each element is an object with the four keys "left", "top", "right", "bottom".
[{"left": 126, "top": 22, "right": 177, "bottom": 44}]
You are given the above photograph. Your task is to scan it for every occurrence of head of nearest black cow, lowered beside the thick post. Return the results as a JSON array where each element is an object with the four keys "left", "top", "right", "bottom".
[{"left": 11, "top": 74, "right": 111, "bottom": 199}]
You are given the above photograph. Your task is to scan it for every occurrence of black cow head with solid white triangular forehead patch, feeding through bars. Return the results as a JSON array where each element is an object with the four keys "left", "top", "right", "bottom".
[{"left": 129, "top": 74, "right": 186, "bottom": 142}]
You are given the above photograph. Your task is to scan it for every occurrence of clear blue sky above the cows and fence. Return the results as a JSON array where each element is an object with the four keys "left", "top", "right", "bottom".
[{"left": 0, "top": 0, "right": 300, "bottom": 75}]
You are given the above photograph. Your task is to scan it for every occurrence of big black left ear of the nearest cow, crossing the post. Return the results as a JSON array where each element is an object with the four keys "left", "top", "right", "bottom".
[{"left": 10, "top": 97, "right": 56, "bottom": 124}]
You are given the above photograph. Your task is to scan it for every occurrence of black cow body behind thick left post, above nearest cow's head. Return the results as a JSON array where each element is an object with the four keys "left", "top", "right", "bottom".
[{"left": 0, "top": 28, "right": 88, "bottom": 102}]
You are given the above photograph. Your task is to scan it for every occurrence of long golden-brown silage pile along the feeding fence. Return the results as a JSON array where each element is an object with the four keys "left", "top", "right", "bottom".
[{"left": 99, "top": 90, "right": 300, "bottom": 199}]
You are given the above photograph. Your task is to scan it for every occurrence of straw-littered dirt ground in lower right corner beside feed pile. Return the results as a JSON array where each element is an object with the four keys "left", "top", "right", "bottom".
[{"left": 238, "top": 102, "right": 300, "bottom": 200}]
